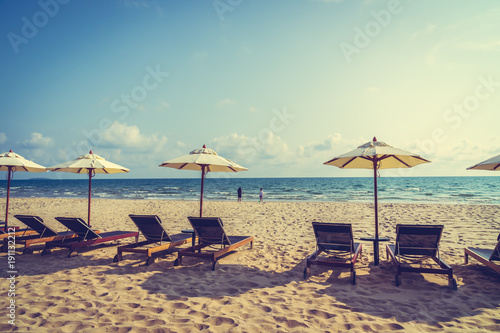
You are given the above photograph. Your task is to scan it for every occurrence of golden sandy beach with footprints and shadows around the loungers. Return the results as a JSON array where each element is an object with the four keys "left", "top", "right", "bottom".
[{"left": 0, "top": 198, "right": 500, "bottom": 332}]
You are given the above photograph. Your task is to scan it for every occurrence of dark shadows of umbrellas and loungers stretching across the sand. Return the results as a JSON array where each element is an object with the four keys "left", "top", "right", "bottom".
[{"left": 6, "top": 245, "right": 500, "bottom": 330}]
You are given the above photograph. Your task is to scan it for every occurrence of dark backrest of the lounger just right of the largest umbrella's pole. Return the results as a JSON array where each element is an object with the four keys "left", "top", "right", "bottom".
[{"left": 396, "top": 224, "right": 444, "bottom": 256}]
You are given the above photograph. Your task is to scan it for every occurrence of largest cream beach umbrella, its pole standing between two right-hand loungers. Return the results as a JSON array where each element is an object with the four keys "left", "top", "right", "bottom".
[{"left": 323, "top": 137, "right": 430, "bottom": 265}]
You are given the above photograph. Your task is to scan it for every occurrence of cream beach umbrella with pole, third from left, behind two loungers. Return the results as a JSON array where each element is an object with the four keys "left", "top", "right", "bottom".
[{"left": 159, "top": 145, "right": 248, "bottom": 217}]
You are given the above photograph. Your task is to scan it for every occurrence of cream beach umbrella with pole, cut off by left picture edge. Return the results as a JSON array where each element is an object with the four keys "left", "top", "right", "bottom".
[{"left": 0, "top": 150, "right": 47, "bottom": 232}]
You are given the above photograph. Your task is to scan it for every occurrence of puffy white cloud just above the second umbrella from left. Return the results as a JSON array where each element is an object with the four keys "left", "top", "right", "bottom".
[{"left": 102, "top": 121, "right": 167, "bottom": 152}]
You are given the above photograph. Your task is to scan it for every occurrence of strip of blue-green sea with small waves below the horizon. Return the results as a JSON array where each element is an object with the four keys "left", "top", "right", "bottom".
[{"left": 0, "top": 175, "right": 500, "bottom": 205}]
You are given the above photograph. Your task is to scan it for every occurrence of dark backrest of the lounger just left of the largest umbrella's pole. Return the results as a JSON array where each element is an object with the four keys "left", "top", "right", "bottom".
[{"left": 312, "top": 222, "right": 355, "bottom": 252}]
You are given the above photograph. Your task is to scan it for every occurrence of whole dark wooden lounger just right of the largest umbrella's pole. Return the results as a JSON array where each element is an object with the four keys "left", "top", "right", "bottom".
[{"left": 386, "top": 224, "right": 457, "bottom": 290}]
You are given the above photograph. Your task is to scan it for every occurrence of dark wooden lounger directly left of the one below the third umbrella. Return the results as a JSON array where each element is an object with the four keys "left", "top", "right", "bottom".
[{"left": 113, "top": 214, "right": 192, "bottom": 266}]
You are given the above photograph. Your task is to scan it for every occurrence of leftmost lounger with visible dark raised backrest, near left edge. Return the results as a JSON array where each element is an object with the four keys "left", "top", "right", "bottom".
[{"left": 14, "top": 215, "right": 82, "bottom": 254}]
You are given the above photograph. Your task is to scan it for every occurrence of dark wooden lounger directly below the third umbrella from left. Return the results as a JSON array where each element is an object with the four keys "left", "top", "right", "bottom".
[{"left": 174, "top": 217, "right": 253, "bottom": 270}]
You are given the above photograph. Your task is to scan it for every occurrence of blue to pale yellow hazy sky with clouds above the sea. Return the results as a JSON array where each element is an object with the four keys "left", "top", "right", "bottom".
[{"left": 0, "top": 0, "right": 500, "bottom": 179}]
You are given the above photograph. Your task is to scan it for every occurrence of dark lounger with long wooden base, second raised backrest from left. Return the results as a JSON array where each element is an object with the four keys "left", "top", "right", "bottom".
[{"left": 42, "top": 217, "right": 139, "bottom": 258}]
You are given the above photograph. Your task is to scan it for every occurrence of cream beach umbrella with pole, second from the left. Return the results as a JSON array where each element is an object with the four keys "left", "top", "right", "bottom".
[{"left": 48, "top": 150, "right": 129, "bottom": 226}]
